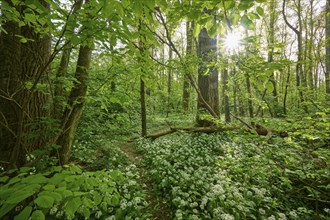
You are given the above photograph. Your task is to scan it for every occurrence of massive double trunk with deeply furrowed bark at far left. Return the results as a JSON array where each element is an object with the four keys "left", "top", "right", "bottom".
[{"left": 0, "top": 1, "right": 50, "bottom": 167}]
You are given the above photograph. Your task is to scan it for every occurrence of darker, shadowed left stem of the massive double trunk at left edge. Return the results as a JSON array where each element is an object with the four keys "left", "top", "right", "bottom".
[{"left": 0, "top": 1, "right": 25, "bottom": 167}]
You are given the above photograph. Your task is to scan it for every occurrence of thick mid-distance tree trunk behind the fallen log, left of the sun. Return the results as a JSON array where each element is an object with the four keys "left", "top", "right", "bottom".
[{"left": 197, "top": 28, "right": 220, "bottom": 123}]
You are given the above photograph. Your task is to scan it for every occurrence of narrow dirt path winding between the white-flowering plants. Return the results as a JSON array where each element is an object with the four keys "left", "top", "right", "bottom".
[{"left": 120, "top": 142, "right": 171, "bottom": 220}]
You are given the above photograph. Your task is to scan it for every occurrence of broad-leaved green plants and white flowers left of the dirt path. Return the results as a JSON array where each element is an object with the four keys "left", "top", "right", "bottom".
[{"left": 0, "top": 165, "right": 146, "bottom": 219}]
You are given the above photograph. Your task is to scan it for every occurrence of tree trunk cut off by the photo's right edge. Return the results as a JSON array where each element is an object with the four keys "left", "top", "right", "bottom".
[{"left": 325, "top": 0, "right": 330, "bottom": 94}]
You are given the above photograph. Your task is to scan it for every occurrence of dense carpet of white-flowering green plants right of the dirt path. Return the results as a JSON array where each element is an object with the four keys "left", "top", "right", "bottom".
[{"left": 139, "top": 133, "right": 330, "bottom": 219}]
